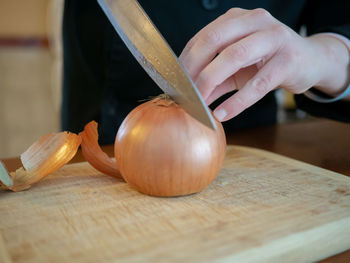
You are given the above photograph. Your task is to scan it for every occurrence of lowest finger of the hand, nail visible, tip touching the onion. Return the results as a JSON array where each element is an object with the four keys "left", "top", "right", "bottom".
[{"left": 214, "top": 56, "right": 289, "bottom": 121}]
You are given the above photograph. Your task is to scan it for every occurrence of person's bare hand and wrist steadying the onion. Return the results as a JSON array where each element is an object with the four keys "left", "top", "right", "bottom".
[{"left": 180, "top": 8, "right": 349, "bottom": 121}]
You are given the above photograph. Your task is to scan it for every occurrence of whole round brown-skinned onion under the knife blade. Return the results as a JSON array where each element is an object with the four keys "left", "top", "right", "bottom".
[{"left": 114, "top": 97, "right": 226, "bottom": 196}]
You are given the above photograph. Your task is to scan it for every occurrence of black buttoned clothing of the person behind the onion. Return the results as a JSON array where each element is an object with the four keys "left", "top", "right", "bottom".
[{"left": 62, "top": 0, "right": 350, "bottom": 143}]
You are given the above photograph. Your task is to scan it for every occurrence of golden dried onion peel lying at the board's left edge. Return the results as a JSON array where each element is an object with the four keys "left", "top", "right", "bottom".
[{"left": 0, "top": 132, "right": 81, "bottom": 191}]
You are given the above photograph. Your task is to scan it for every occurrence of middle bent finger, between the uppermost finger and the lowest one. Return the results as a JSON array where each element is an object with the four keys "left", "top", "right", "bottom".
[{"left": 196, "top": 26, "right": 282, "bottom": 100}]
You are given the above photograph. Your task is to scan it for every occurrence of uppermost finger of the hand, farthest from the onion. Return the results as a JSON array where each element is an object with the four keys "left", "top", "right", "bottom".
[{"left": 180, "top": 8, "right": 275, "bottom": 80}]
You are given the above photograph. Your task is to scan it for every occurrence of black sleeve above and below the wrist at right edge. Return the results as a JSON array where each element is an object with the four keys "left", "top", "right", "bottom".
[{"left": 295, "top": 0, "right": 350, "bottom": 122}]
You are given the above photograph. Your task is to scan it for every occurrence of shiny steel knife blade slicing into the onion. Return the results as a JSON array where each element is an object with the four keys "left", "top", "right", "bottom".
[{"left": 97, "top": 0, "right": 216, "bottom": 130}]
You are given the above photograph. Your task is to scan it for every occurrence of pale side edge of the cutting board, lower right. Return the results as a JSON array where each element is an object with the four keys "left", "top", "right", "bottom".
[{"left": 215, "top": 217, "right": 350, "bottom": 263}]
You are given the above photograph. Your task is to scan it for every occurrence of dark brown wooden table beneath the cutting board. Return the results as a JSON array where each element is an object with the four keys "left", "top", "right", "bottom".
[{"left": 1, "top": 119, "right": 350, "bottom": 263}]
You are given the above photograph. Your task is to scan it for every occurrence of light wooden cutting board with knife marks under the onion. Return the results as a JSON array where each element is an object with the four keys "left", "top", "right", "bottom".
[{"left": 0, "top": 146, "right": 350, "bottom": 263}]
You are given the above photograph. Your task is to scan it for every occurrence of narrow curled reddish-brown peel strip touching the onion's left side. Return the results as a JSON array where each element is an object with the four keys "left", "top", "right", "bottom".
[{"left": 79, "top": 121, "right": 123, "bottom": 179}]
